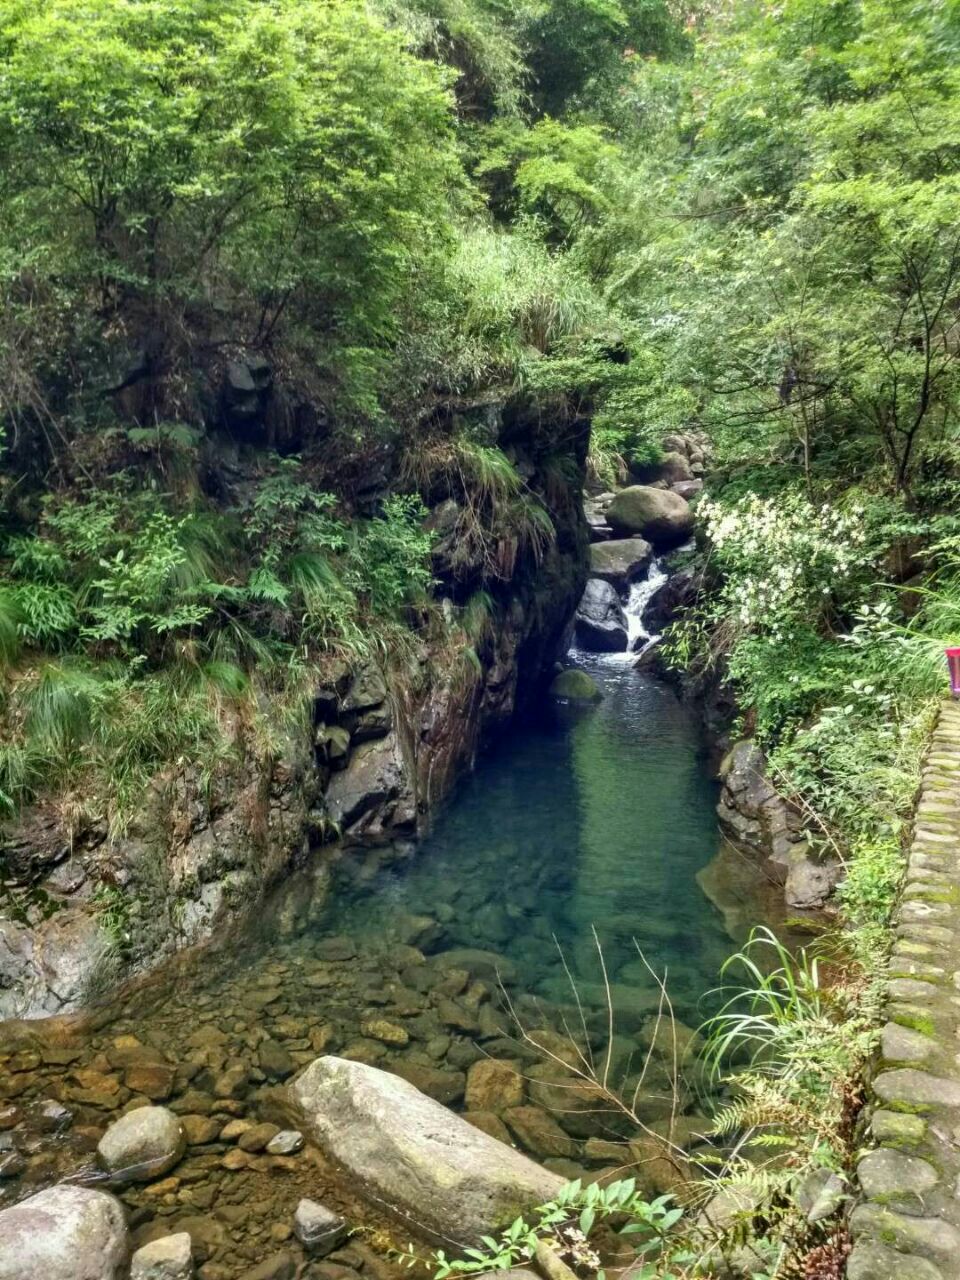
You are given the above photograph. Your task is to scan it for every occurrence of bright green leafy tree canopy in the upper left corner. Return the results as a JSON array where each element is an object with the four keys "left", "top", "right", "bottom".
[{"left": 0, "top": 0, "right": 458, "bottom": 404}]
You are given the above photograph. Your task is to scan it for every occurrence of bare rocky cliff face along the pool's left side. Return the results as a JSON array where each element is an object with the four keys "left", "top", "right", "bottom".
[{"left": 0, "top": 394, "right": 589, "bottom": 1018}]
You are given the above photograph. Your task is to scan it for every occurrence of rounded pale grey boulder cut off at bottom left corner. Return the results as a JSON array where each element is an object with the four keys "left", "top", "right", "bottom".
[{"left": 0, "top": 1183, "right": 128, "bottom": 1280}]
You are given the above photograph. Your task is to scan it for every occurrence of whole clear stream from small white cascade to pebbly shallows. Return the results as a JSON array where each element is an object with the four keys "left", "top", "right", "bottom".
[{"left": 0, "top": 564, "right": 773, "bottom": 1280}]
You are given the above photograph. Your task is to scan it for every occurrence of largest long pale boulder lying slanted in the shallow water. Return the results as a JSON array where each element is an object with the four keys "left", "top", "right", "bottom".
[{"left": 291, "top": 1057, "right": 563, "bottom": 1243}]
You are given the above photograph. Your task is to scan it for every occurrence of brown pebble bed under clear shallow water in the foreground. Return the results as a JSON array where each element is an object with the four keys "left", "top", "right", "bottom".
[{"left": 0, "top": 880, "right": 721, "bottom": 1280}]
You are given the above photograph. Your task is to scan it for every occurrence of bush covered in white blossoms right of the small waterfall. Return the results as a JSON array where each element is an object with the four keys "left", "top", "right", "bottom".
[{"left": 698, "top": 493, "right": 873, "bottom": 641}]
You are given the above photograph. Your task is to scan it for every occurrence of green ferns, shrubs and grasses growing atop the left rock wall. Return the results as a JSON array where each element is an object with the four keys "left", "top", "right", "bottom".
[{"left": 0, "top": 460, "right": 431, "bottom": 826}]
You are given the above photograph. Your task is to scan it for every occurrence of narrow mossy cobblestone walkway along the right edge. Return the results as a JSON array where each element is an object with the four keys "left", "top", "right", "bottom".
[{"left": 847, "top": 703, "right": 960, "bottom": 1280}]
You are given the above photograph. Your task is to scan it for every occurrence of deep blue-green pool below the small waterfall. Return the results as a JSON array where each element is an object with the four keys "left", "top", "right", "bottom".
[{"left": 334, "top": 653, "right": 731, "bottom": 1019}]
